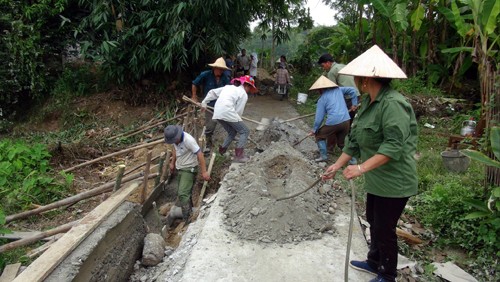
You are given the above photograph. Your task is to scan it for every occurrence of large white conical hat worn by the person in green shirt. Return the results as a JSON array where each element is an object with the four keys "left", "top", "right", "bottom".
[{"left": 339, "top": 45, "right": 406, "bottom": 78}]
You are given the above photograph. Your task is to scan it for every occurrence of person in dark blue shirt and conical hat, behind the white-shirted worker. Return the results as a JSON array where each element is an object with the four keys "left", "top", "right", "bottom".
[{"left": 191, "top": 57, "right": 230, "bottom": 153}]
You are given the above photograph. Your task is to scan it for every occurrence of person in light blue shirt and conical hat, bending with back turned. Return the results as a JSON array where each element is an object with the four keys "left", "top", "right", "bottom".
[{"left": 309, "top": 75, "right": 358, "bottom": 162}]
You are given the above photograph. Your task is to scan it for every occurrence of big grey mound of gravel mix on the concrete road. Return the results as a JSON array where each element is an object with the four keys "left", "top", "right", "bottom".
[{"left": 221, "top": 142, "right": 335, "bottom": 243}]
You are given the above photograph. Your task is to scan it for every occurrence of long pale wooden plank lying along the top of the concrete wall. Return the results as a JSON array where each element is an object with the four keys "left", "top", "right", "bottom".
[{"left": 14, "top": 182, "right": 139, "bottom": 282}]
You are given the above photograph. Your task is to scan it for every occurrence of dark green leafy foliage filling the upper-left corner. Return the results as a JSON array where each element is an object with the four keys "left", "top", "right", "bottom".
[{"left": 0, "top": 0, "right": 81, "bottom": 119}]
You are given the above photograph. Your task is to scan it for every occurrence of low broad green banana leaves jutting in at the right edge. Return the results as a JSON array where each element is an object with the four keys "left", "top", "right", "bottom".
[{"left": 460, "top": 126, "right": 500, "bottom": 219}]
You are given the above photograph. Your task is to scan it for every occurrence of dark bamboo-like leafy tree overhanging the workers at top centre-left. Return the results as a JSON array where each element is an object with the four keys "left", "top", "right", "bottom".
[{"left": 77, "top": 0, "right": 254, "bottom": 83}]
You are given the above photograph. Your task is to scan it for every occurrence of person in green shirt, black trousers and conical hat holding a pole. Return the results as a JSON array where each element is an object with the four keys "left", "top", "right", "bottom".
[{"left": 322, "top": 45, "right": 418, "bottom": 282}]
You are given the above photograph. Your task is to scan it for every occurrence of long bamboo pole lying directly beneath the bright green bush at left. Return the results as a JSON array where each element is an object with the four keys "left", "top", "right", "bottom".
[{"left": 5, "top": 173, "right": 156, "bottom": 223}]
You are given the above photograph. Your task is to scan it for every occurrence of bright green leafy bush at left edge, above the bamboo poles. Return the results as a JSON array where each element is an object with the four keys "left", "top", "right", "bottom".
[{"left": 0, "top": 139, "right": 73, "bottom": 213}]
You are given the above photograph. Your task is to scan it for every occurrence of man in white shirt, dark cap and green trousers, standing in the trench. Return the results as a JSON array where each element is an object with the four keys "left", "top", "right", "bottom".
[{"left": 165, "top": 125, "right": 210, "bottom": 223}]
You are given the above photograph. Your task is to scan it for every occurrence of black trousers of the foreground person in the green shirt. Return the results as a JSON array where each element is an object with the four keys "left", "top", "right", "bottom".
[{"left": 366, "top": 194, "right": 408, "bottom": 281}]
